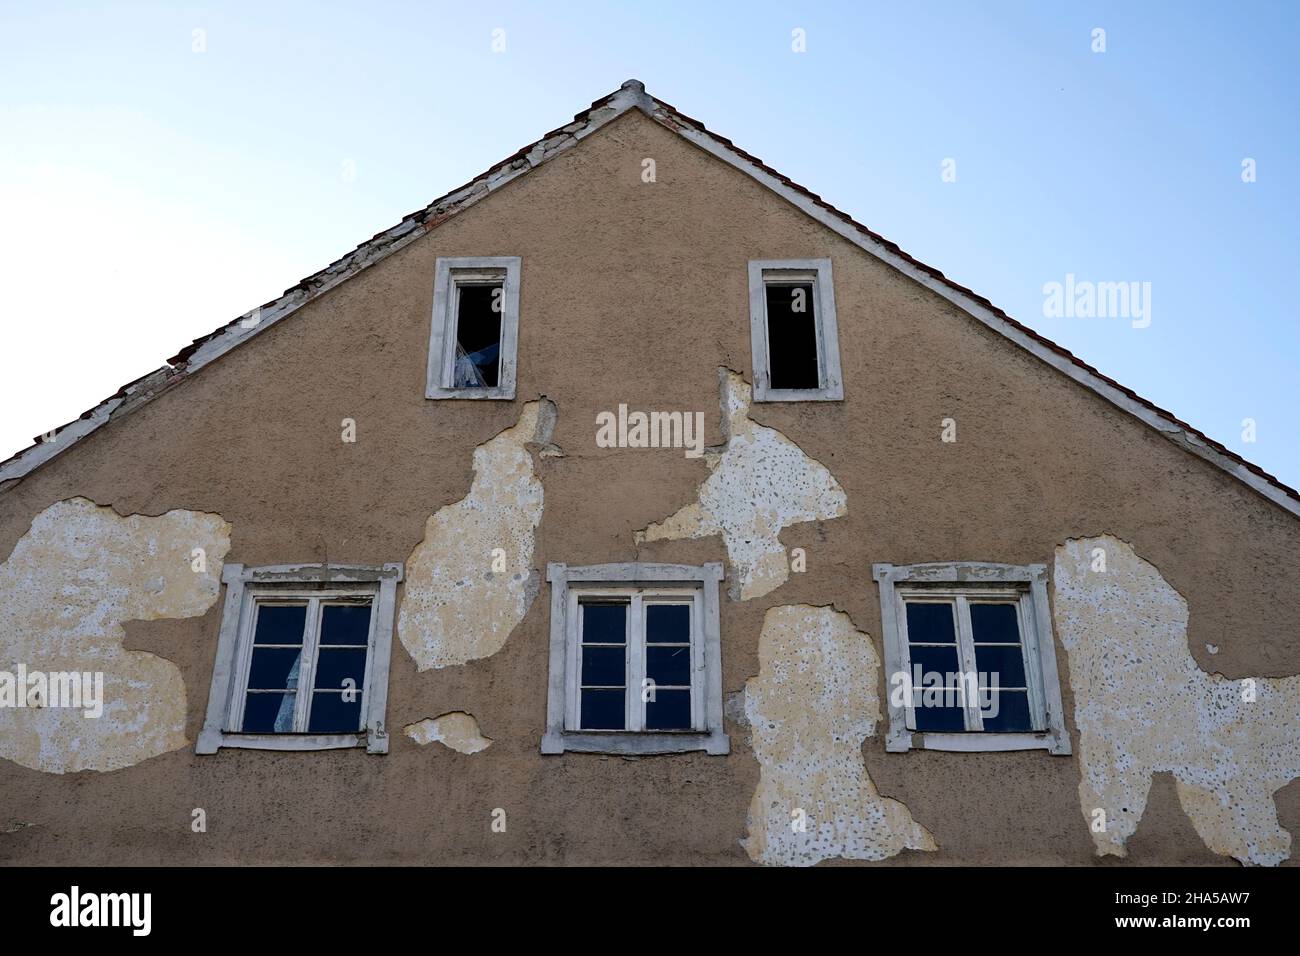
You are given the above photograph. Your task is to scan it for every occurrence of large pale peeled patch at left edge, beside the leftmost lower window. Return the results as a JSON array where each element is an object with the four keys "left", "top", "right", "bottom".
[{"left": 0, "top": 498, "right": 230, "bottom": 774}]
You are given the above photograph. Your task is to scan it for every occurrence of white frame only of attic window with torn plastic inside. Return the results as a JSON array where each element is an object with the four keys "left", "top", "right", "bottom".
[{"left": 424, "top": 256, "right": 521, "bottom": 399}]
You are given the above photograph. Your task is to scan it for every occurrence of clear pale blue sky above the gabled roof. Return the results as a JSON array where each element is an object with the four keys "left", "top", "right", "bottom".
[{"left": 0, "top": 0, "right": 1300, "bottom": 486}]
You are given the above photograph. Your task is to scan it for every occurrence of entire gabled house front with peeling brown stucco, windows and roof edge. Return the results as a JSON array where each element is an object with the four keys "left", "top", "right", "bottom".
[{"left": 0, "top": 81, "right": 1300, "bottom": 865}]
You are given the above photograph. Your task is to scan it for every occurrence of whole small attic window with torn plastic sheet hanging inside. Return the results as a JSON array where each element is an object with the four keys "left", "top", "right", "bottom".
[{"left": 425, "top": 256, "right": 520, "bottom": 399}]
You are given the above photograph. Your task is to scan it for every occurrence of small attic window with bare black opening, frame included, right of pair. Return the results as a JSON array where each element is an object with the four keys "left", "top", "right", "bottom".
[{"left": 749, "top": 259, "right": 844, "bottom": 402}]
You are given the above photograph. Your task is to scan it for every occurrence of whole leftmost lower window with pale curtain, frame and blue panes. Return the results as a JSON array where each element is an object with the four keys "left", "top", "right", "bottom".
[{"left": 196, "top": 564, "right": 402, "bottom": 753}]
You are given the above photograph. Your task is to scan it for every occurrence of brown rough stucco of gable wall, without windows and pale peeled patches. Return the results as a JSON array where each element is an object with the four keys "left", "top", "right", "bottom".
[{"left": 0, "top": 113, "right": 1300, "bottom": 865}]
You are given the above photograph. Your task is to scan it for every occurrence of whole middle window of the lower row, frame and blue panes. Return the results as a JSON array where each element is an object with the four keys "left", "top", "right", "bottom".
[{"left": 542, "top": 563, "right": 731, "bottom": 753}]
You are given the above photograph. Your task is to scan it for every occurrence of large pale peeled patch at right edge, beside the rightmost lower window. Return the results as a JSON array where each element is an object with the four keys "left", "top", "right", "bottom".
[{"left": 1056, "top": 536, "right": 1300, "bottom": 865}]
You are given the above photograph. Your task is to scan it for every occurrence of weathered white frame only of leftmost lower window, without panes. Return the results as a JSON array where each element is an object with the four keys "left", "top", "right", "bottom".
[{"left": 195, "top": 563, "right": 402, "bottom": 753}]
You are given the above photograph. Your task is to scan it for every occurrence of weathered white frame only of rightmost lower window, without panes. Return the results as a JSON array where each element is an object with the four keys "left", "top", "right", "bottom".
[{"left": 871, "top": 562, "right": 1070, "bottom": 754}]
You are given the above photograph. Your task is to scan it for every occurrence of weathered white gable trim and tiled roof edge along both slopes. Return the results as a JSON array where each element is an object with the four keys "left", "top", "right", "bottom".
[{"left": 0, "top": 79, "right": 1300, "bottom": 528}]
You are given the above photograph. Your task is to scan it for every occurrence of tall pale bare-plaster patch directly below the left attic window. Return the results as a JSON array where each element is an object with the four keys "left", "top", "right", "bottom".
[{"left": 398, "top": 399, "right": 558, "bottom": 670}]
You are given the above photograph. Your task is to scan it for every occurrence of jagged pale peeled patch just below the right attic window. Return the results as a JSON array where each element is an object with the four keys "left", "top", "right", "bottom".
[{"left": 636, "top": 368, "right": 846, "bottom": 601}]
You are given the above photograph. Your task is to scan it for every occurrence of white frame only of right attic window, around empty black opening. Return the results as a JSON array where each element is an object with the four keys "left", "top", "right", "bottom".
[{"left": 749, "top": 259, "right": 844, "bottom": 402}]
